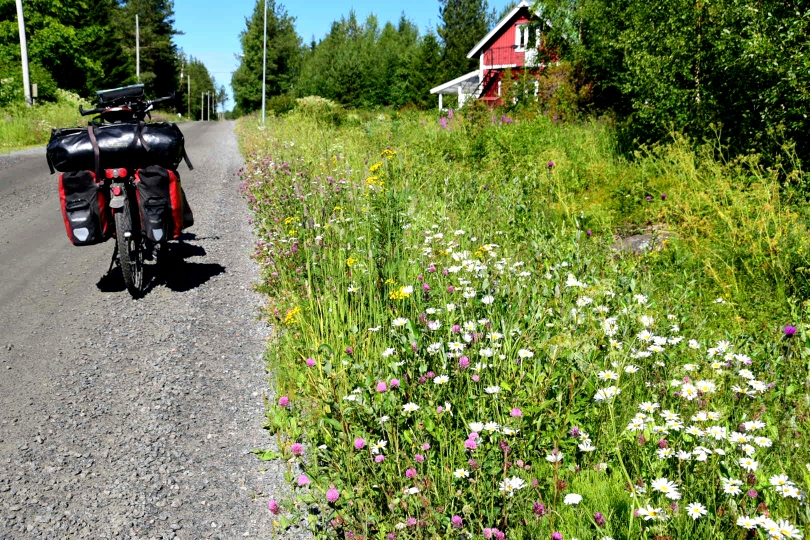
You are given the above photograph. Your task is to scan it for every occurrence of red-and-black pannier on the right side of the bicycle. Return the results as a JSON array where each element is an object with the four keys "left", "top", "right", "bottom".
[{"left": 135, "top": 165, "right": 194, "bottom": 242}]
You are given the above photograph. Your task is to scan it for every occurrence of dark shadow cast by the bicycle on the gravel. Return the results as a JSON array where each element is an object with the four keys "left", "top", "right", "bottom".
[{"left": 96, "top": 233, "right": 225, "bottom": 294}]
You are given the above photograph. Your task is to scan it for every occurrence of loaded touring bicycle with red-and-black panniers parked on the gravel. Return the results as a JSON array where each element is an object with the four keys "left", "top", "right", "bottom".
[{"left": 46, "top": 84, "right": 194, "bottom": 297}]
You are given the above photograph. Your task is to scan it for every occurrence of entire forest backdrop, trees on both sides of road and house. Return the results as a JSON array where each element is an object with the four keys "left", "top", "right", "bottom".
[{"left": 0, "top": 0, "right": 810, "bottom": 166}]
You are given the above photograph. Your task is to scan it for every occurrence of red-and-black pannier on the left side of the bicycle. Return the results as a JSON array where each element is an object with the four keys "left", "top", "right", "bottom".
[{"left": 59, "top": 171, "right": 113, "bottom": 246}]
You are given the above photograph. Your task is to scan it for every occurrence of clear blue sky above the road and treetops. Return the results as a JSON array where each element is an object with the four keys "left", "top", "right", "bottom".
[{"left": 174, "top": 0, "right": 508, "bottom": 109}]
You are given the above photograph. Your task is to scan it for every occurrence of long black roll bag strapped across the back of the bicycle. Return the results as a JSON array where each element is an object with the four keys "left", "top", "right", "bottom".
[{"left": 47, "top": 122, "right": 185, "bottom": 172}]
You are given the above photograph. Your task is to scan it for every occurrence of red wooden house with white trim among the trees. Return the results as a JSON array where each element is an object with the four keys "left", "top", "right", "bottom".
[{"left": 430, "top": 0, "right": 543, "bottom": 110}]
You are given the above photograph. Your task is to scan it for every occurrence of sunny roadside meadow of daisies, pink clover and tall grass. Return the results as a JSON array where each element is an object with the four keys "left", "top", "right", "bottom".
[{"left": 238, "top": 103, "right": 810, "bottom": 540}]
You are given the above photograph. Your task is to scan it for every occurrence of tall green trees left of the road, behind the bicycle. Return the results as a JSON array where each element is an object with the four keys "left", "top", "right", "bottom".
[{"left": 0, "top": 0, "right": 224, "bottom": 118}]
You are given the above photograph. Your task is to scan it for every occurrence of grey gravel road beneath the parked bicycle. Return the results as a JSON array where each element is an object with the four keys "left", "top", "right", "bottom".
[{"left": 0, "top": 122, "right": 294, "bottom": 539}]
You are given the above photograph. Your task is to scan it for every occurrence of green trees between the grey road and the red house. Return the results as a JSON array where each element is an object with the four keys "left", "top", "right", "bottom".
[{"left": 231, "top": 0, "right": 490, "bottom": 113}]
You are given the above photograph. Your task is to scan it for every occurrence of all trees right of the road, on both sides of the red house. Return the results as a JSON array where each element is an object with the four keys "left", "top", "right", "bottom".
[{"left": 232, "top": 0, "right": 810, "bottom": 165}]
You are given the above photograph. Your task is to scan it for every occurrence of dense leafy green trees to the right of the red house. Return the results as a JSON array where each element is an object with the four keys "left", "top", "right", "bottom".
[{"left": 542, "top": 0, "right": 810, "bottom": 162}]
